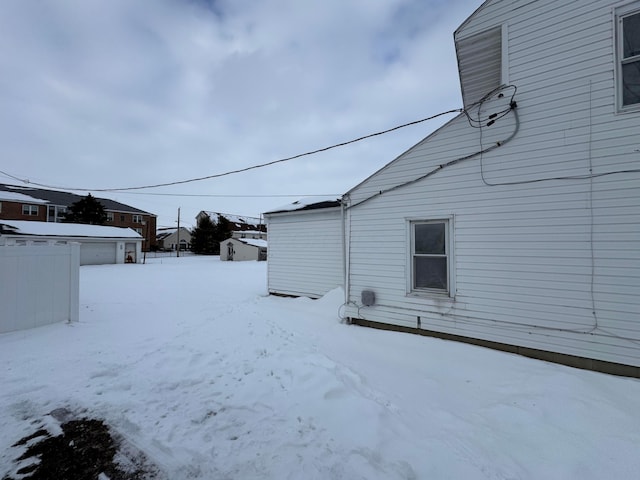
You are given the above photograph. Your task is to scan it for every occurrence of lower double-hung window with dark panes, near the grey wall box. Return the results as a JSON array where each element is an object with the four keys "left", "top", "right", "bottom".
[{"left": 411, "top": 220, "right": 451, "bottom": 293}]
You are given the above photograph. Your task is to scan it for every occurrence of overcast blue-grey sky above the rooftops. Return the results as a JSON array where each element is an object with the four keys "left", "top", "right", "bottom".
[{"left": 0, "top": 0, "right": 482, "bottom": 226}]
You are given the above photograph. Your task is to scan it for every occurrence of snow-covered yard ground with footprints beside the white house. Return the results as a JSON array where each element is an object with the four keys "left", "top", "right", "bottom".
[{"left": 0, "top": 257, "right": 640, "bottom": 480}]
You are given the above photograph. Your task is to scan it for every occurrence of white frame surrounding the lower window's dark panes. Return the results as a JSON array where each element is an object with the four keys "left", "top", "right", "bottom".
[{"left": 407, "top": 215, "right": 456, "bottom": 298}]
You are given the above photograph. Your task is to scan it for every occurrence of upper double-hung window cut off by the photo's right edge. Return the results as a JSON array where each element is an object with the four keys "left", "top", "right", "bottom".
[{"left": 617, "top": 2, "right": 640, "bottom": 109}]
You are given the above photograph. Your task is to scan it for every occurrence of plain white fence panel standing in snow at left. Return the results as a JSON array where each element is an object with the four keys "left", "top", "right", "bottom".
[{"left": 0, "top": 243, "right": 80, "bottom": 333}]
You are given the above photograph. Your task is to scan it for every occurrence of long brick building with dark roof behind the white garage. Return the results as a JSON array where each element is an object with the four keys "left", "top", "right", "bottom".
[{"left": 0, "top": 184, "right": 156, "bottom": 250}]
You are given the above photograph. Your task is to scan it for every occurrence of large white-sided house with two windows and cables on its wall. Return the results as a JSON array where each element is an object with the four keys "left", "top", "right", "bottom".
[{"left": 340, "top": 0, "right": 640, "bottom": 376}]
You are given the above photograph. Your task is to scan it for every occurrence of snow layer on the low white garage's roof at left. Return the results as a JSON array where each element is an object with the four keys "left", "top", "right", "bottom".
[{"left": 0, "top": 220, "right": 142, "bottom": 238}]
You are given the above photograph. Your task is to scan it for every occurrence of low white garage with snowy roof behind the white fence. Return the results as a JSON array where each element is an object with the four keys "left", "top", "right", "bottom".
[{"left": 0, "top": 220, "right": 143, "bottom": 265}]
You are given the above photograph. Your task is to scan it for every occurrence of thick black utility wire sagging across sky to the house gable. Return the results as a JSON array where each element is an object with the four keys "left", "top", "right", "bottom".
[{"left": 0, "top": 108, "right": 464, "bottom": 192}]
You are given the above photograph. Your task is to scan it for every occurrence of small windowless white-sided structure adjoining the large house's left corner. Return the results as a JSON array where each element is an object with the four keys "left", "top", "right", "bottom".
[{"left": 264, "top": 197, "right": 344, "bottom": 298}]
